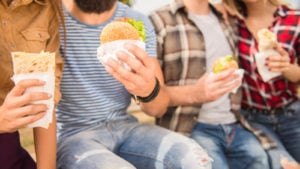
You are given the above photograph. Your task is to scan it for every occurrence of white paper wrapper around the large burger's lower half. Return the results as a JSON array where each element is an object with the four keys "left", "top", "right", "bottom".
[{"left": 97, "top": 40, "right": 145, "bottom": 70}]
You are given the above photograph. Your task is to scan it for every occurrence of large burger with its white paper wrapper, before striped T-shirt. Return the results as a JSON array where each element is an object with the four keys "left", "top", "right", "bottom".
[{"left": 97, "top": 18, "right": 146, "bottom": 69}]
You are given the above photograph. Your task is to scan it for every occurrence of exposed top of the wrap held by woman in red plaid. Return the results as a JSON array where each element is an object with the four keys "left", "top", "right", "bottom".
[{"left": 257, "top": 28, "right": 278, "bottom": 51}]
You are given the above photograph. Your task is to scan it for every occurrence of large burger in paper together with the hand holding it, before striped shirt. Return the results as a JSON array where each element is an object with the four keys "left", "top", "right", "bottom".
[{"left": 98, "top": 18, "right": 160, "bottom": 102}]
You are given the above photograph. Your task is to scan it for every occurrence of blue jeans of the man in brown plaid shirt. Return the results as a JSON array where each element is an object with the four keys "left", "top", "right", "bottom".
[{"left": 191, "top": 122, "right": 269, "bottom": 169}]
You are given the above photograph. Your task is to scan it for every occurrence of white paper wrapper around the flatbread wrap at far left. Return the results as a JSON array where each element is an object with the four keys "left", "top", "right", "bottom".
[{"left": 12, "top": 72, "right": 55, "bottom": 128}]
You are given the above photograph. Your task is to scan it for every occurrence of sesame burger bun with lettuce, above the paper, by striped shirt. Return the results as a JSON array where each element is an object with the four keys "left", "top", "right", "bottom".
[{"left": 100, "top": 18, "right": 146, "bottom": 44}]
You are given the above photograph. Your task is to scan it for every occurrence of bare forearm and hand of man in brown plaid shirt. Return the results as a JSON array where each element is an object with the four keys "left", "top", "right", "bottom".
[{"left": 167, "top": 69, "right": 241, "bottom": 106}]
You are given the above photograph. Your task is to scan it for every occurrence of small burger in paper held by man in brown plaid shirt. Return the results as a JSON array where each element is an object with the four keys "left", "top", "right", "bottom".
[{"left": 212, "top": 55, "right": 244, "bottom": 93}]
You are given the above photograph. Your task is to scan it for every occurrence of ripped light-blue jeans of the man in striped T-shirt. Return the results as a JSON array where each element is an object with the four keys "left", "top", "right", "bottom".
[{"left": 57, "top": 115, "right": 211, "bottom": 169}]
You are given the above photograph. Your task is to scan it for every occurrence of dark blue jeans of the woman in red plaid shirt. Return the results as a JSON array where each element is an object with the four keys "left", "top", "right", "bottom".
[{"left": 242, "top": 101, "right": 300, "bottom": 169}]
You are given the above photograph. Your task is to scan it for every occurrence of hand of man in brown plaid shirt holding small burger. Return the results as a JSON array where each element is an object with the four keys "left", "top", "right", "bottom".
[{"left": 194, "top": 69, "right": 241, "bottom": 103}]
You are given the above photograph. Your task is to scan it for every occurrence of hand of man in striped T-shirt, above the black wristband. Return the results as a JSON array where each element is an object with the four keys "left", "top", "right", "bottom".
[{"left": 105, "top": 44, "right": 156, "bottom": 97}]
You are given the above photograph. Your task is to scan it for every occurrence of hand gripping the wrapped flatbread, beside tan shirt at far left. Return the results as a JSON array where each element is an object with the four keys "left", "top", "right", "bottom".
[{"left": 0, "top": 80, "right": 51, "bottom": 133}]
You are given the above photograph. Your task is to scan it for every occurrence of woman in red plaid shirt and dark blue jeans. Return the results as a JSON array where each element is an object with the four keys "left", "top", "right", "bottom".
[{"left": 227, "top": 0, "right": 300, "bottom": 169}]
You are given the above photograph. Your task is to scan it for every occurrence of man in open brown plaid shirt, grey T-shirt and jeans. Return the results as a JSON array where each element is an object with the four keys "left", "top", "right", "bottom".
[{"left": 150, "top": 0, "right": 269, "bottom": 169}]
